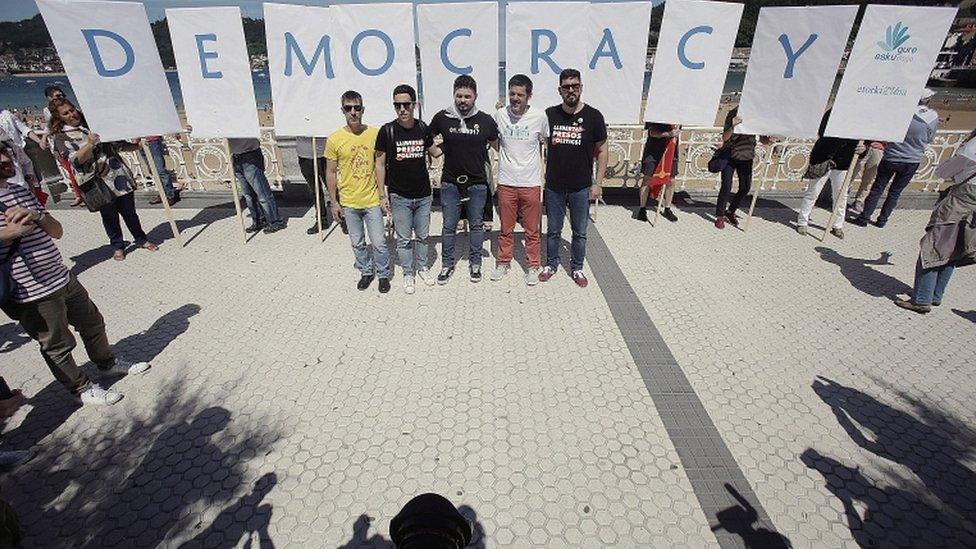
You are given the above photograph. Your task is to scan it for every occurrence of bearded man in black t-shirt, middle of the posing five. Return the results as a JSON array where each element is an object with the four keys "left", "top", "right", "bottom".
[{"left": 430, "top": 74, "right": 498, "bottom": 284}]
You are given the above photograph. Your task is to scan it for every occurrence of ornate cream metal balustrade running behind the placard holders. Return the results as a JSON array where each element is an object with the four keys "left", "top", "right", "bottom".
[{"left": 126, "top": 125, "right": 968, "bottom": 191}]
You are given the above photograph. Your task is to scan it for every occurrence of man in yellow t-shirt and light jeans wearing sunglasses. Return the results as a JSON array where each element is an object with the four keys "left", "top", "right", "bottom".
[{"left": 325, "top": 90, "right": 390, "bottom": 294}]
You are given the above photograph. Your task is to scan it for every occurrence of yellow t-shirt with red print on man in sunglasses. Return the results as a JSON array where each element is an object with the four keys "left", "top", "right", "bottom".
[{"left": 325, "top": 126, "right": 380, "bottom": 208}]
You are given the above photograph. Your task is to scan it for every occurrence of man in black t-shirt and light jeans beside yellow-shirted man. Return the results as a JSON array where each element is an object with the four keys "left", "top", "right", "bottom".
[{"left": 376, "top": 84, "right": 440, "bottom": 294}]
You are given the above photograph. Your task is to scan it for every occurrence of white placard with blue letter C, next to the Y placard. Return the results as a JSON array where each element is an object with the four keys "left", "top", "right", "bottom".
[{"left": 644, "top": 0, "right": 742, "bottom": 126}]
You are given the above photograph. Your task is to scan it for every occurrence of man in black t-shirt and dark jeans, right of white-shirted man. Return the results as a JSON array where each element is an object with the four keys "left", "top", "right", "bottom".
[{"left": 539, "top": 69, "right": 607, "bottom": 288}]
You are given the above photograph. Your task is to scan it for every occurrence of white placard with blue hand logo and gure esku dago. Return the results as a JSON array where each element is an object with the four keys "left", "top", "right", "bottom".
[{"left": 826, "top": 6, "right": 956, "bottom": 142}]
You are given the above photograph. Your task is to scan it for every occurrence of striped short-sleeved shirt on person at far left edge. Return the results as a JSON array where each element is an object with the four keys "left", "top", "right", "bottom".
[{"left": 0, "top": 184, "right": 71, "bottom": 303}]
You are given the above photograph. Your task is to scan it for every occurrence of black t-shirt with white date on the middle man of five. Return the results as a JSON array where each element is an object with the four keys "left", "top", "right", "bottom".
[{"left": 430, "top": 111, "right": 498, "bottom": 183}]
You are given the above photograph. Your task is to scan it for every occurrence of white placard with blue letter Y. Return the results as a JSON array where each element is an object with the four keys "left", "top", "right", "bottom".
[{"left": 736, "top": 6, "right": 857, "bottom": 138}]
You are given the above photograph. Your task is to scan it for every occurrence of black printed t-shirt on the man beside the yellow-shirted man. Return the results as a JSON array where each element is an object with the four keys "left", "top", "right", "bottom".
[{"left": 376, "top": 120, "right": 434, "bottom": 198}]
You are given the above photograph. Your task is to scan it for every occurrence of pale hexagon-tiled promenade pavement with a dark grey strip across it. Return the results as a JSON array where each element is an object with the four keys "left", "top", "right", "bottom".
[{"left": 0, "top": 199, "right": 976, "bottom": 548}]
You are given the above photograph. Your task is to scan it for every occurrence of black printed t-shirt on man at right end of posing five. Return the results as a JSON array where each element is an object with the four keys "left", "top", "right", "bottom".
[{"left": 546, "top": 105, "right": 607, "bottom": 191}]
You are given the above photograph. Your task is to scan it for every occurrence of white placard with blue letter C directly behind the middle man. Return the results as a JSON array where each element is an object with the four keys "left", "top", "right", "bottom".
[{"left": 418, "top": 2, "right": 504, "bottom": 119}]
